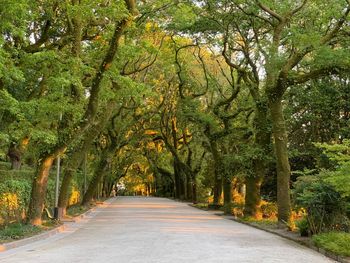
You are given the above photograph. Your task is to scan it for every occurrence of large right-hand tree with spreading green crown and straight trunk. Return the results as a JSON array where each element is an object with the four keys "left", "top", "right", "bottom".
[{"left": 189, "top": 0, "right": 349, "bottom": 226}]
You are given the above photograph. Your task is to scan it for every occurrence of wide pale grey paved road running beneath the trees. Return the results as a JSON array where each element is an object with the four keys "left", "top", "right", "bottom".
[{"left": 0, "top": 197, "right": 333, "bottom": 263}]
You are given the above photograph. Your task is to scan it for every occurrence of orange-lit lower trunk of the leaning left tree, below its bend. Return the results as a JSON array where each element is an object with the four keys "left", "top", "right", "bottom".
[{"left": 27, "top": 155, "right": 56, "bottom": 225}]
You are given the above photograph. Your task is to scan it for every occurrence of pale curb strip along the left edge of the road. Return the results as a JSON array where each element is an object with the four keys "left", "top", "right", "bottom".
[{"left": 0, "top": 199, "right": 110, "bottom": 253}]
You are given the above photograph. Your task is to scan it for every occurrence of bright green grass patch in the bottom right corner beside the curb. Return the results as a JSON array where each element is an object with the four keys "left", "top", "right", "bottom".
[{"left": 312, "top": 232, "right": 350, "bottom": 257}]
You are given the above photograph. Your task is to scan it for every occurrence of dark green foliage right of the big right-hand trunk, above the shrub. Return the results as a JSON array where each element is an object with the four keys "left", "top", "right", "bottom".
[{"left": 284, "top": 76, "right": 350, "bottom": 154}]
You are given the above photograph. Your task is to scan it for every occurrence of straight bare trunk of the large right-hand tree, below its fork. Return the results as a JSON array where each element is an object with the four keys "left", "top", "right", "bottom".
[{"left": 269, "top": 99, "right": 291, "bottom": 225}]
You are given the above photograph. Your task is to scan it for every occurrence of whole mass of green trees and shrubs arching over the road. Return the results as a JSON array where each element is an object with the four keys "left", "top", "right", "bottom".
[{"left": 0, "top": 0, "right": 350, "bottom": 252}]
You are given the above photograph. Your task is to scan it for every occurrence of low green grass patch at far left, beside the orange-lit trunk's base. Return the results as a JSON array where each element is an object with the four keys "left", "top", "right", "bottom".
[{"left": 0, "top": 223, "right": 44, "bottom": 243}]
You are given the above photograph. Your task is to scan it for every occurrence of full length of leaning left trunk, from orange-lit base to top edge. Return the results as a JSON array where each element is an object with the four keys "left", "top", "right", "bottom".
[{"left": 28, "top": 1, "right": 135, "bottom": 225}]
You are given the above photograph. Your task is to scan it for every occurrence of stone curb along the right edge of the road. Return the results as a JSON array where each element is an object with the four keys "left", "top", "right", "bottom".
[{"left": 189, "top": 204, "right": 350, "bottom": 263}]
